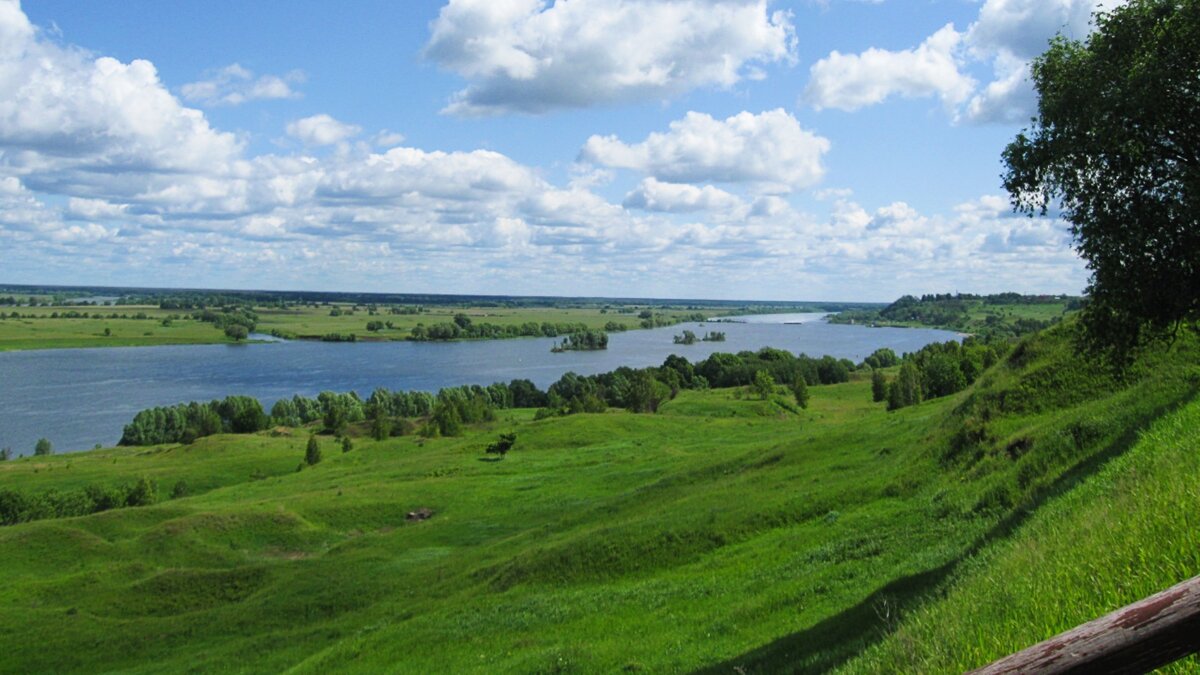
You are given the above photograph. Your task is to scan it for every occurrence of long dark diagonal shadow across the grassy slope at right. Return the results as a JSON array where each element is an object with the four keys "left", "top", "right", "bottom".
[{"left": 696, "top": 388, "right": 1196, "bottom": 675}]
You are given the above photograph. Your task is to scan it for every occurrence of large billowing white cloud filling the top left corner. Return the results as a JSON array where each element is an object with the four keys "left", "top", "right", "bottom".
[{"left": 0, "top": 1, "right": 241, "bottom": 176}]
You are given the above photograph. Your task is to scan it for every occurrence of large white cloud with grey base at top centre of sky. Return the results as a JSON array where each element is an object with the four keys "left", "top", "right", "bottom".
[{"left": 425, "top": 0, "right": 794, "bottom": 115}]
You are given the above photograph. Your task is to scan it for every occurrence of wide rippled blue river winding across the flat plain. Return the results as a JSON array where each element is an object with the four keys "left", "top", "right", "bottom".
[{"left": 0, "top": 315, "right": 959, "bottom": 455}]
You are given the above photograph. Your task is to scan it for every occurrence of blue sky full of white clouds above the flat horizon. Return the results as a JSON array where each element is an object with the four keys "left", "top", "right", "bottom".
[{"left": 0, "top": 0, "right": 1111, "bottom": 300}]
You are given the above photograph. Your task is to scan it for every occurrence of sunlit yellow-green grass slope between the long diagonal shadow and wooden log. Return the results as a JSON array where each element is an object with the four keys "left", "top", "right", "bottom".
[{"left": 846, "top": 393, "right": 1200, "bottom": 673}]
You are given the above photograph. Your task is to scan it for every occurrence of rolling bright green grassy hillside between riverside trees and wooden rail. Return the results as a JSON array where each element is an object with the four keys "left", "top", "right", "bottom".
[{"left": 0, "top": 328, "right": 1200, "bottom": 673}]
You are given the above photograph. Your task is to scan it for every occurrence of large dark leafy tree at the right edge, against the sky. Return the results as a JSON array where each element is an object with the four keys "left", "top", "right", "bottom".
[{"left": 1003, "top": 0, "right": 1200, "bottom": 365}]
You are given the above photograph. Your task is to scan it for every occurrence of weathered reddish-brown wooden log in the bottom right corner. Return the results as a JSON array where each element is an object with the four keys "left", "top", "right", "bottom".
[{"left": 971, "top": 577, "right": 1200, "bottom": 675}]
